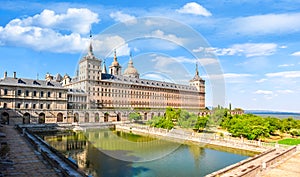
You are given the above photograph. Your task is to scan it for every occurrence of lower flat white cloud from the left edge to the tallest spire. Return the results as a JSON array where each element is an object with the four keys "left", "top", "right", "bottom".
[{"left": 0, "top": 22, "right": 89, "bottom": 53}]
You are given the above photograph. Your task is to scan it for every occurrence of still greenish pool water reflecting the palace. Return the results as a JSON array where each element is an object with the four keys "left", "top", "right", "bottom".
[{"left": 40, "top": 129, "right": 254, "bottom": 177}]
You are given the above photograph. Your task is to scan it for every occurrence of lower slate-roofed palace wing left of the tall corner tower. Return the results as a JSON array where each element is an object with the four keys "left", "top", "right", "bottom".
[{"left": 0, "top": 73, "right": 68, "bottom": 124}]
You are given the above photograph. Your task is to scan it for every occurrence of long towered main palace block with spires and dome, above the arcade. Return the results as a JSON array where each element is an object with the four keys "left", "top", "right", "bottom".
[{"left": 64, "top": 41, "right": 205, "bottom": 111}]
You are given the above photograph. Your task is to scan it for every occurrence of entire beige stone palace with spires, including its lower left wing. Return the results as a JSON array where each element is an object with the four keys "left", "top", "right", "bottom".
[{"left": 0, "top": 42, "right": 205, "bottom": 123}]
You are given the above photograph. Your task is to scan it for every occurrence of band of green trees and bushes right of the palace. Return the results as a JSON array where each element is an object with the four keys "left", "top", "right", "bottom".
[{"left": 148, "top": 106, "right": 300, "bottom": 140}]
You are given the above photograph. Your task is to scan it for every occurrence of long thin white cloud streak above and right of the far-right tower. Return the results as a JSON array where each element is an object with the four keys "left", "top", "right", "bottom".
[{"left": 192, "top": 43, "right": 278, "bottom": 57}]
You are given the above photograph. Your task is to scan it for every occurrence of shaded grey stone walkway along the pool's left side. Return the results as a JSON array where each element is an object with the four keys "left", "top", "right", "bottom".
[{"left": 0, "top": 125, "right": 60, "bottom": 177}]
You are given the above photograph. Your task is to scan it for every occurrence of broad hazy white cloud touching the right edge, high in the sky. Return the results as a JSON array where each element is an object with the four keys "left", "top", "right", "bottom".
[{"left": 229, "top": 13, "right": 300, "bottom": 35}]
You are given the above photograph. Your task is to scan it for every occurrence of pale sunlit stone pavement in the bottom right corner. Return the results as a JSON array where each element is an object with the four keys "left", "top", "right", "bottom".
[{"left": 262, "top": 151, "right": 300, "bottom": 177}]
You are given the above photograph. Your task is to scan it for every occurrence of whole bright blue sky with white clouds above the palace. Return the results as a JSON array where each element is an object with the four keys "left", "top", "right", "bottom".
[{"left": 0, "top": 0, "right": 300, "bottom": 112}]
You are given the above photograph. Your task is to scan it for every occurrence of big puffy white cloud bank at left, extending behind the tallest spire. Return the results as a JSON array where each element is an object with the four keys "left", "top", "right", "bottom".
[{"left": 0, "top": 8, "right": 129, "bottom": 56}]
